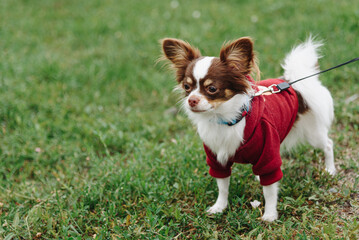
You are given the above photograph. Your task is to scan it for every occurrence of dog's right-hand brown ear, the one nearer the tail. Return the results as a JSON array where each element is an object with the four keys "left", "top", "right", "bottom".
[{"left": 220, "top": 37, "right": 255, "bottom": 75}]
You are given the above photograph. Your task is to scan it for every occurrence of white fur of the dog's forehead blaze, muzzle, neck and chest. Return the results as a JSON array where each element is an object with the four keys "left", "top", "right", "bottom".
[{"left": 183, "top": 57, "right": 253, "bottom": 165}]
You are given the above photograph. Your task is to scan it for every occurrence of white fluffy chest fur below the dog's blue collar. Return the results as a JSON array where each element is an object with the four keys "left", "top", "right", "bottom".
[{"left": 197, "top": 118, "right": 246, "bottom": 165}]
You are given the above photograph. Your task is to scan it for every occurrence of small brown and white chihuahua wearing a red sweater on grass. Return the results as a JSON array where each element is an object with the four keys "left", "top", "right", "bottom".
[{"left": 162, "top": 37, "right": 336, "bottom": 222}]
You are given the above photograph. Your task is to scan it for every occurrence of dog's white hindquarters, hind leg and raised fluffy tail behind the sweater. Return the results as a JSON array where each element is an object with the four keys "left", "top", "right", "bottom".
[{"left": 282, "top": 38, "right": 336, "bottom": 175}]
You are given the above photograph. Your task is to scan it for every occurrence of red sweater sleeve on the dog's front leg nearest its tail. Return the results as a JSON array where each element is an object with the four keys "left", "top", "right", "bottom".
[{"left": 252, "top": 119, "right": 283, "bottom": 186}]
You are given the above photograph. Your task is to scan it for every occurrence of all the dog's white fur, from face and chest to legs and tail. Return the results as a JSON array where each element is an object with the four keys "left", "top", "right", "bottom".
[{"left": 183, "top": 38, "right": 336, "bottom": 222}]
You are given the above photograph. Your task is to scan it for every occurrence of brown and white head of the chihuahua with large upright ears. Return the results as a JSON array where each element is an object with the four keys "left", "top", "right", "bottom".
[{"left": 162, "top": 37, "right": 258, "bottom": 113}]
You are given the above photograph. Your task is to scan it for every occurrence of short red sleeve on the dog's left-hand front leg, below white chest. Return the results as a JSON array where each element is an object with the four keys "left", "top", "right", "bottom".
[{"left": 203, "top": 144, "right": 233, "bottom": 178}]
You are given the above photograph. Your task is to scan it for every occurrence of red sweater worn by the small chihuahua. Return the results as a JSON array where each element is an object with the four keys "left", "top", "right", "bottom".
[{"left": 204, "top": 79, "right": 298, "bottom": 186}]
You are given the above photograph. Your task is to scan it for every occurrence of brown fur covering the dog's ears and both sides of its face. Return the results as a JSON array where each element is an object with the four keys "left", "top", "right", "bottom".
[{"left": 162, "top": 38, "right": 259, "bottom": 105}]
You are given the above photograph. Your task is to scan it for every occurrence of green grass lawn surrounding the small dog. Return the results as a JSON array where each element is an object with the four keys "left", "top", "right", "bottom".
[{"left": 0, "top": 0, "right": 359, "bottom": 239}]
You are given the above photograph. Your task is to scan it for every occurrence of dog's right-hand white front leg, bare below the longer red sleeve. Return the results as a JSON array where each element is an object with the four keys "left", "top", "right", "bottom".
[{"left": 262, "top": 182, "right": 279, "bottom": 222}]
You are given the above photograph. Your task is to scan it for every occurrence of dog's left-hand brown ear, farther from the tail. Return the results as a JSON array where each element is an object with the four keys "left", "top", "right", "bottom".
[{"left": 162, "top": 38, "right": 201, "bottom": 70}]
